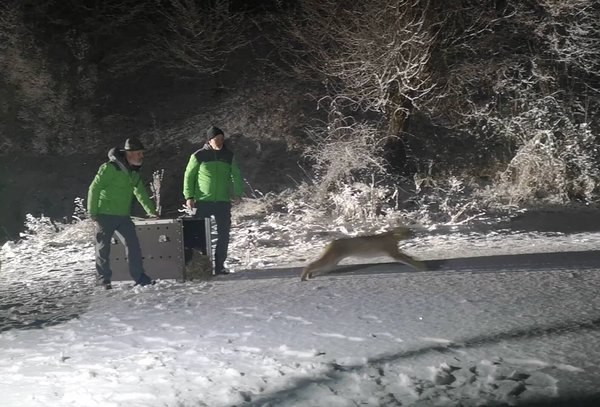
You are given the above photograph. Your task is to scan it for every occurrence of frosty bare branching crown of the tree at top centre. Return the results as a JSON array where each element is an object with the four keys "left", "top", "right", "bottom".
[{"left": 275, "top": 0, "right": 437, "bottom": 136}]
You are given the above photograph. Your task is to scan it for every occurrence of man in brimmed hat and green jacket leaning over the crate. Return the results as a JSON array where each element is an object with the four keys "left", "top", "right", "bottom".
[{"left": 87, "top": 138, "right": 157, "bottom": 289}]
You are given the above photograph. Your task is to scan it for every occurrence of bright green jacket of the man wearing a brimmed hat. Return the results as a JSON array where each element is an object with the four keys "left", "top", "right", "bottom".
[{"left": 87, "top": 148, "right": 156, "bottom": 217}]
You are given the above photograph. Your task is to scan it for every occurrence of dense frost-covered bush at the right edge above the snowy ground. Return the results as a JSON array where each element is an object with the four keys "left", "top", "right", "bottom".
[{"left": 486, "top": 92, "right": 600, "bottom": 206}]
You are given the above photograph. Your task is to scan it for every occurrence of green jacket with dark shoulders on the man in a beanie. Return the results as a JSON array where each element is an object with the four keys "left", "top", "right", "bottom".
[{"left": 183, "top": 144, "right": 244, "bottom": 202}]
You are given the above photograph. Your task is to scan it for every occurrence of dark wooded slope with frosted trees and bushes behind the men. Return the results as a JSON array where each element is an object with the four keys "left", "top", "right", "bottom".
[{"left": 0, "top": 0, "right": 600, "bottom": 240}]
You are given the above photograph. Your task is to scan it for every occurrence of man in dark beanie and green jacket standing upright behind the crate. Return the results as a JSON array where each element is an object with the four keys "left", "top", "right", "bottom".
[{"left": 183, "top": 126, "right": 244, "bottom": 274}]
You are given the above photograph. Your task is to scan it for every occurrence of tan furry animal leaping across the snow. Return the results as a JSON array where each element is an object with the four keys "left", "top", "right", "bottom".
[{"left": 300, "top": 227, "right": 426, "bottom": 281}]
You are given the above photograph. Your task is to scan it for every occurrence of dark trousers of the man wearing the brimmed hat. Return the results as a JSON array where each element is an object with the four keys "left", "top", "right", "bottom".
[{"left": 96, "top": 215, "right": 144, "bottom": 282}]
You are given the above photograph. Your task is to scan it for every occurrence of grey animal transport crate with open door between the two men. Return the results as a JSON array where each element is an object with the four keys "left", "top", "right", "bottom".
[{"left": 110, "top": 218, "right": 212, "bottom": 281}]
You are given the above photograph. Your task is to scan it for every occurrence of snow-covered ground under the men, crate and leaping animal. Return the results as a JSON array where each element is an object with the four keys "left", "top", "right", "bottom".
[{"left": 0, "top": 209, "right": 600, "bottom": 407}]
